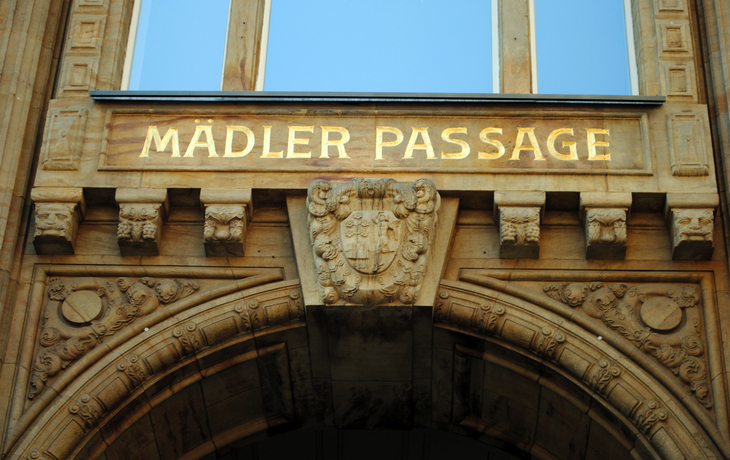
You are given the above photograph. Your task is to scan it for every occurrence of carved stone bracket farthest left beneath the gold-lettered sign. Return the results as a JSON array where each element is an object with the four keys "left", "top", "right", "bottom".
[{"left": 30, "top": 187, "right": 86, "bottom": 255}]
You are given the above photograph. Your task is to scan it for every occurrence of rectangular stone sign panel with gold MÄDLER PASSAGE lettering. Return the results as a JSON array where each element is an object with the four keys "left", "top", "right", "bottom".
[{"left": 100, "top": 113, "right": 651, "bottom": 174}]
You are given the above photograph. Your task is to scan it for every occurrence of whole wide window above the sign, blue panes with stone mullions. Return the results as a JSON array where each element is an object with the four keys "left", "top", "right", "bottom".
[{"left": 123, "top": 0, "right": 638, "bottom": 95}]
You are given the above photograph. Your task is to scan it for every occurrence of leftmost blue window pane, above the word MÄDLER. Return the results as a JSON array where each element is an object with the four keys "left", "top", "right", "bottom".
[{"left": 128, "top": 0, "right": 229, "bottom": 91}]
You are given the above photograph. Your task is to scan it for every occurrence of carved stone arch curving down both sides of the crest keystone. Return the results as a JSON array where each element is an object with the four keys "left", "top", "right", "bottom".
[{"left": 8, "top": 275, "right": 724, "bottom": 459}]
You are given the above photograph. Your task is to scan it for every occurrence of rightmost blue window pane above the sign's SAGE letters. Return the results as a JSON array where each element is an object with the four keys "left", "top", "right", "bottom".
[{"left": 534, "top": 0, "right": 632, "bottom": 95}]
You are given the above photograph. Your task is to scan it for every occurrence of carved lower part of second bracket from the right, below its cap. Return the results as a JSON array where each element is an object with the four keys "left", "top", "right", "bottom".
[{"left": 585, "top": 208, "right": 626, "bottom": 260}]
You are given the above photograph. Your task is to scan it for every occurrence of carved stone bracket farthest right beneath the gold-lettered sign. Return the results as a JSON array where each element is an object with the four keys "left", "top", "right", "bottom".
[{"left": 665, "top": 193, "right": 720, "bottom": 260}]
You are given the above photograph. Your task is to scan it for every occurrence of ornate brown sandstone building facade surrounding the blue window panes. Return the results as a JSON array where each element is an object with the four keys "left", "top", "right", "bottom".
[{"left": 0, "top": 0, "right": 730, "bottom": 460}]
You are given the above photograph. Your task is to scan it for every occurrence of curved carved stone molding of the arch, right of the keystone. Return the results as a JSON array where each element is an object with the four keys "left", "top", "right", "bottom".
[{"left": 434, "top": 275, "right": 728, "bottom": 460}]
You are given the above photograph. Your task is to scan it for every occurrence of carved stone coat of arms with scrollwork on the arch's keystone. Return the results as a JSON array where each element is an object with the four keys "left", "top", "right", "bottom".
[{"left": 307, "top": 179, "right": 441, "bottom": 305}]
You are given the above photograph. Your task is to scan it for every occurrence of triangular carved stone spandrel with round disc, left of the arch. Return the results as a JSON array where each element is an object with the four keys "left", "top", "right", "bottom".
[{"left": 28, "top": 278, "right": 199, "bottom": 399}]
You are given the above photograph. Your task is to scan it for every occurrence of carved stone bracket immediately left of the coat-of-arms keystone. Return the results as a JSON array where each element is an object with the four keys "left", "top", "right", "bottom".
[{"left": 200, "top": 189, "right": 252, "bottom": 257}]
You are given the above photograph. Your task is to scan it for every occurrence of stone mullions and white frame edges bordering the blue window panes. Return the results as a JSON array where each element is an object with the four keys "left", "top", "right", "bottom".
[{"left": 121, "top": 0, "right": 641, "bottom": 96}]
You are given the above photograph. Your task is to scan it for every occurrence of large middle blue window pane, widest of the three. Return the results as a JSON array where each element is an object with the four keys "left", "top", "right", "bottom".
[{"left": 264, "top": 0, "right": 492, "bottom": 93}]
